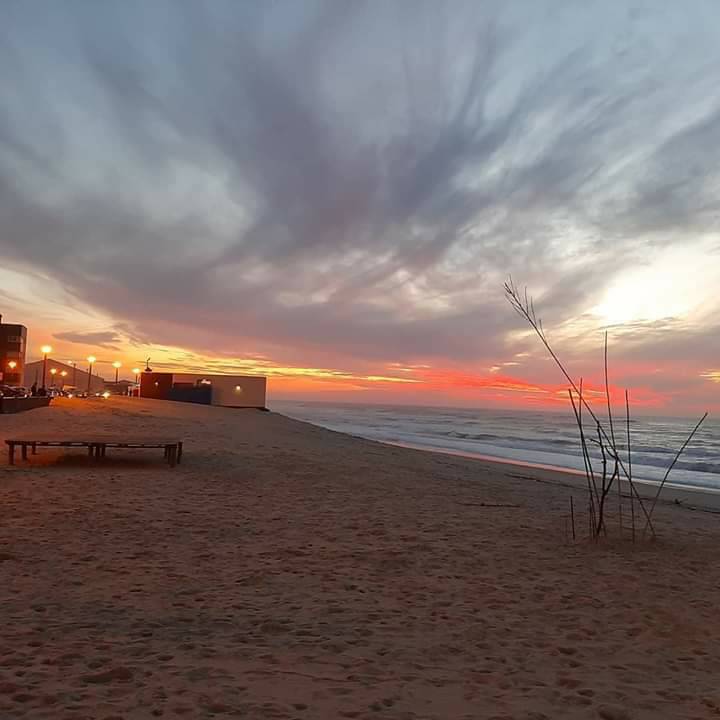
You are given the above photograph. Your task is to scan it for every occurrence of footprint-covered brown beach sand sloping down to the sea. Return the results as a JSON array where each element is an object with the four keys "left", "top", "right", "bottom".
[{"left": 0, "top": 398, "right": 720, "bottom": 720}]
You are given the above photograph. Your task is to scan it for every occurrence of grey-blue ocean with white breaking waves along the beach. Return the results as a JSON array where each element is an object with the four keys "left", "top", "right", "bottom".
[{"left": 271, "top": 401, "right": 720, "bottom": 490}]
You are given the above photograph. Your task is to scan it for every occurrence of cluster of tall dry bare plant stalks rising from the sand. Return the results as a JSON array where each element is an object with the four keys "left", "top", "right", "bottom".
[{"left": 504, "top": 277, "right": 708, "bottom": 542}]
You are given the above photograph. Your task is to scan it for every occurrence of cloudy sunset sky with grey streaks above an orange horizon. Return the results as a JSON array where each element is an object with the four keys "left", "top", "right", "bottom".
[{"left": 0, "top": 0, "right": 720, "bottom": 415}]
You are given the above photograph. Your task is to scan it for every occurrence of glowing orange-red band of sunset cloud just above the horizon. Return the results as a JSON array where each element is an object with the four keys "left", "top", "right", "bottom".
[{"left": 22, "top": 330, "right": 692, "bottom": 410}]
